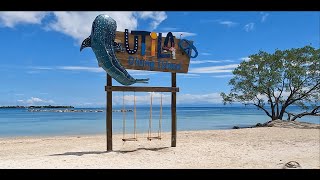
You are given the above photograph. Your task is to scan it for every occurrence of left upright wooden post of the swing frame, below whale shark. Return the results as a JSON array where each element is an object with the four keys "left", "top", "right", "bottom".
[{"left": 106, "top": 74, "right": 112, "bottom": 151}]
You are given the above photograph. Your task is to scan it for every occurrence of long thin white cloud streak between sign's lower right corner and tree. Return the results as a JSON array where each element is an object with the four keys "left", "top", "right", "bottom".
[{"left": 189, "top": 64, "right": 239, "bottom": 73}]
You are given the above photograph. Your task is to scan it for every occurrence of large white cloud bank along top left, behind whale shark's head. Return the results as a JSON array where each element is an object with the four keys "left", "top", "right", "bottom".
[{"left": 0, "top": 11, "right": 167, "bottom": 44}]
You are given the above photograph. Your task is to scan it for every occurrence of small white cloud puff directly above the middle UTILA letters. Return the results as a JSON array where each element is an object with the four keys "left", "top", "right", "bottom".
[{"left": 138, "top": 11, "right": 167, "bottom": 30}]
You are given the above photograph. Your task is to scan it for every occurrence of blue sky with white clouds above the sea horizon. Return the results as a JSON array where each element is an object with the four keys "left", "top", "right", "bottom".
[{"left": 0, "top": 11, "right": 320, "bottom": 107}]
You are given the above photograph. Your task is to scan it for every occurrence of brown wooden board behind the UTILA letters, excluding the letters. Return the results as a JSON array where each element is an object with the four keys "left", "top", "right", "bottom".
[{"left": 115, "top": 31, "right": 190, "bottom": 73}]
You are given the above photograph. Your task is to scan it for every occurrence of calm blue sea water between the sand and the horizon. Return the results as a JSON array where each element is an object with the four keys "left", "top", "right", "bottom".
[{"left": 0, "top": 107, "right": 320, "bottom": 137}]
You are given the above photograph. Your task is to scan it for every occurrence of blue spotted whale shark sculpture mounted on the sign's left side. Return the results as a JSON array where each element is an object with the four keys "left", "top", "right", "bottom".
[{"left": 80, "top": 14, "right": 149, "bottom": 85}]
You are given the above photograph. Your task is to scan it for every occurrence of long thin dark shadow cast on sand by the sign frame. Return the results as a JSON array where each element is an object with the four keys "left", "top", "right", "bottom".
[{"left": 49, "top": 147, "right": 169, "bottom": 156}]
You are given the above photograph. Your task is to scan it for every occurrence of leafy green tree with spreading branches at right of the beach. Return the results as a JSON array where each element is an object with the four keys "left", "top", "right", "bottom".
[{"left": 220, "top": 46, "right": 320, "bottom": 121}]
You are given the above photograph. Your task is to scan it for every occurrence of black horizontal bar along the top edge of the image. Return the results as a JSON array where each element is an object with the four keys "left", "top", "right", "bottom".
[{"left": 0, "top": 0, "right": 320, "bottom": 11}]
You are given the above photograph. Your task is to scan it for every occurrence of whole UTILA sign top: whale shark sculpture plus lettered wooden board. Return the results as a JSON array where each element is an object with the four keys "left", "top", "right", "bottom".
[{"left": 80, "top": 14, "right": 198, "bottom": 85}]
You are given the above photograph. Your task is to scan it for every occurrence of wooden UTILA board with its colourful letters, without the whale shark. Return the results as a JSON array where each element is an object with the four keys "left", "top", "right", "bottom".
[{"left": 115, "top": 29, "right": 198, "bottom": 73}]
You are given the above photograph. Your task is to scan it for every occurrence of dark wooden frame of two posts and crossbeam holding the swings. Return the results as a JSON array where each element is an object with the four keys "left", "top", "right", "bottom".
[{"left": 105, "top": 72, "right": 179, "bottom": 151}]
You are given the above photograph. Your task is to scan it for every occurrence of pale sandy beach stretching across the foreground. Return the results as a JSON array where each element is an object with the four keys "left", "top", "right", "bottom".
[{"left": 0, "top": 127, "right": 320, "bottom": 169}]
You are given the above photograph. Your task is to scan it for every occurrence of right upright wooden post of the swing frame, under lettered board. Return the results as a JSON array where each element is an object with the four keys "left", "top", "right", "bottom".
[{"left": 171, "top": 73, "right": 177, "bottom": 147}]
